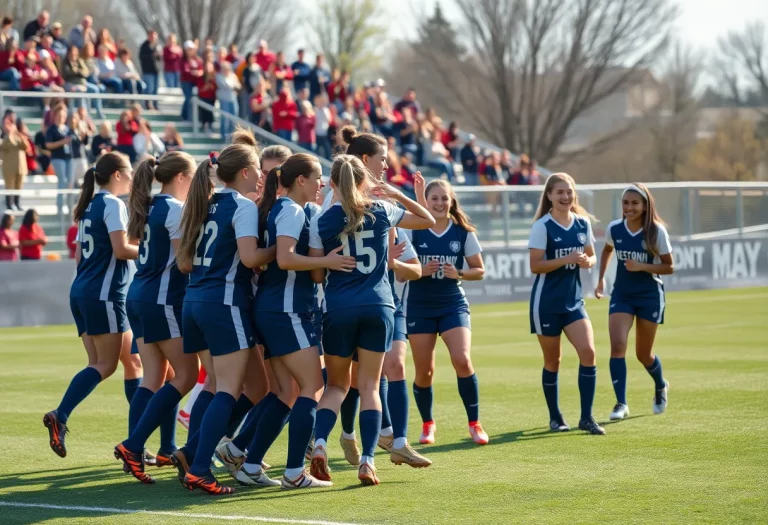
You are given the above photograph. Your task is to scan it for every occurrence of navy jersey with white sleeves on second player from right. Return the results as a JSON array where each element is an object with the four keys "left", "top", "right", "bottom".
[{"left": 528, "top": 213, "right": 595, "bottom": 313}]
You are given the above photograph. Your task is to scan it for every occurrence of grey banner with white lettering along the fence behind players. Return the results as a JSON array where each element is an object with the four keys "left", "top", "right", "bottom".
[{"left": 0, "top": 239, "right": 768, "bottom": 326}]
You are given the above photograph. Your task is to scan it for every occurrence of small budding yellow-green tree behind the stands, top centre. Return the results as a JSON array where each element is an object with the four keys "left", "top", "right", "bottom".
[{"left": 307, "top": 0, "right": 386, "bottom": 75}]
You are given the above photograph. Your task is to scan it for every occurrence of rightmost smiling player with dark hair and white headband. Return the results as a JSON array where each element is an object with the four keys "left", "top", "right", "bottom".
[{"left": 595, "top": 184, "right": 674, "bottom": 420}]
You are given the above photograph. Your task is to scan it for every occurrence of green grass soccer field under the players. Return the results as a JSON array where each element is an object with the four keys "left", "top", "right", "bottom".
[{"left": 0, "top": 288, "right": 768, "bottom": 525}]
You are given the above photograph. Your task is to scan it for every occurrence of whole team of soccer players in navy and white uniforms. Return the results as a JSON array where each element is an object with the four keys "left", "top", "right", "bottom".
[{"left": 43, "top": 127, "right": 673, "bottom": 494}]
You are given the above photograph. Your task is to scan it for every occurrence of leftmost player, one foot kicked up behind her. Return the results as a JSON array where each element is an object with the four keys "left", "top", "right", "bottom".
[{"left": 43, "top": 153, "right": 138, "bottom": 457}]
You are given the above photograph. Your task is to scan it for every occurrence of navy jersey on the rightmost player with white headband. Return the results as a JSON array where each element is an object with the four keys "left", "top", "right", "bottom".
[{"left": 605, "top": 219, "right": 672, "bottom": 299}]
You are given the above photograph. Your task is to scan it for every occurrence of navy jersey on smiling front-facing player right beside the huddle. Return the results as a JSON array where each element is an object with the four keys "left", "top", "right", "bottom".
[{"left": 403, "top": 221, "right": 482, "bottom": 317}]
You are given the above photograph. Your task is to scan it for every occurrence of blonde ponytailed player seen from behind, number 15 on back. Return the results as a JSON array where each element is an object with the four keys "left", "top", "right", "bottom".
[{"left": 309, "top": 155, "right": 435, "bottom": 485}]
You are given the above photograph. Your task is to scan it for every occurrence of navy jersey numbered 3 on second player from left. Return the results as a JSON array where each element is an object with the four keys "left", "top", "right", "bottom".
[{"left": 128, "top": 194, "right": 189, "bottom": 306}]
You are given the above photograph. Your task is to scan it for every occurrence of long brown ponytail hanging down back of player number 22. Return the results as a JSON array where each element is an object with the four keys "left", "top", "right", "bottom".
[{"left": 176, "top": 159, "right": 214, "bottom": 268}]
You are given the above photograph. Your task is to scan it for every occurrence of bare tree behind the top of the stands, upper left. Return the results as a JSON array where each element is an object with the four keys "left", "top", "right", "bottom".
[{"left": 118, "top": 0, "right": 294, "bottom": 50}]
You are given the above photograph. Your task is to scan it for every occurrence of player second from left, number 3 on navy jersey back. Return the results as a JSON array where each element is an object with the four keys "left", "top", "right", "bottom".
[{"left": 115, "top": 151, "right": 199, "bottom": 483}]
